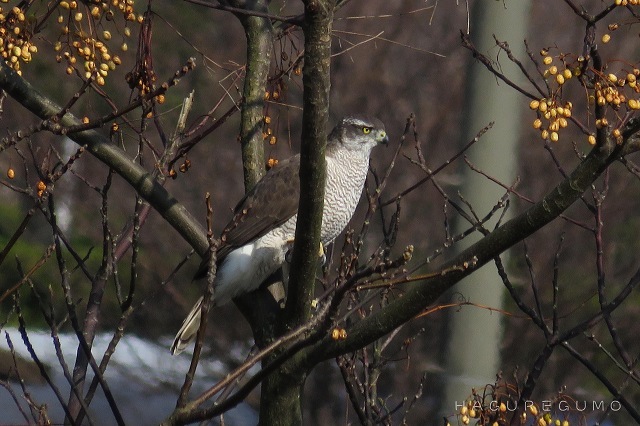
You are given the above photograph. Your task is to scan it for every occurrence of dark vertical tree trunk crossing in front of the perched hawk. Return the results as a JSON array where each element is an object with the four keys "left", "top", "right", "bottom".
[{"left": 260, "top": 0, "right": 335, "bottom": 426}]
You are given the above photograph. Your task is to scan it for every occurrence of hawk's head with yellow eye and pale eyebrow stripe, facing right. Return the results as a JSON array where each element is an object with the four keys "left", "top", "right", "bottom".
[{"left": 328, "top": 115, "right": 389, "bottom": 154}]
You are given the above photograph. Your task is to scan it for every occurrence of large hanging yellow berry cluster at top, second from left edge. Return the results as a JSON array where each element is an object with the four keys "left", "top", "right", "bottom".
[{"left": 54, "top": 0, "right": 143, "bottom": 86}]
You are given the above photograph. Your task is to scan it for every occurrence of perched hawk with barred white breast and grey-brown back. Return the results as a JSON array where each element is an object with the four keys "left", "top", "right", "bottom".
[{"left": 171, "top": 115, "right": 389, "bottom": 355}]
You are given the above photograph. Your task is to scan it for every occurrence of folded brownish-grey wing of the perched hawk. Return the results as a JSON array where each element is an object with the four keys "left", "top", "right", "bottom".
[{"left": 194, "top": 155, "right": 300, "bottom": 279}]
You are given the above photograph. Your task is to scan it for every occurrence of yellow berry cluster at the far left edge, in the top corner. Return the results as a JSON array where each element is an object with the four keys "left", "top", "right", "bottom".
[{"left": 0, "top": 0, "right": 38, "bottom": 75}]
